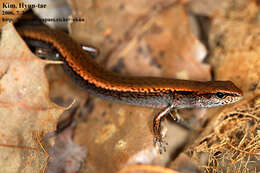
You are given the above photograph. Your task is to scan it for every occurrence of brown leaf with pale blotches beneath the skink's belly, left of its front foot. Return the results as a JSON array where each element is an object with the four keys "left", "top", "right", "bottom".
[{"left": 75, "top": 99, "right": 158, "bottom": 173}]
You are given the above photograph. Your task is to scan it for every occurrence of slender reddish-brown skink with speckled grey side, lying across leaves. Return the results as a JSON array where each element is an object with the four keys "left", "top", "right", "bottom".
[{"left": 18, "top": 27, "right": 243, "bottom": 150}]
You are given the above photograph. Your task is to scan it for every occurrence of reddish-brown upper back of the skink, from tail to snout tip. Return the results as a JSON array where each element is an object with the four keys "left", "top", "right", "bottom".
[{"left": 18, "top": 27, "right": 244, "bottom": 94}]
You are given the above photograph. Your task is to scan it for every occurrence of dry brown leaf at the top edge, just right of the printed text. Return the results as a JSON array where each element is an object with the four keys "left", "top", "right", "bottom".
[{"left": 70, "top": 0, "right": 180, "bottom": 58}]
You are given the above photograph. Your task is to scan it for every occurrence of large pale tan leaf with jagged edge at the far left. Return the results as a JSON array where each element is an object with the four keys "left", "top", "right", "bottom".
[{"left": 0, "top": 24, "right": 64, "bottom": 172}]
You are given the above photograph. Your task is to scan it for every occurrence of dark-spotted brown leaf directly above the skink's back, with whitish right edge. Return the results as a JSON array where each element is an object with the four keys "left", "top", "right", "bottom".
[{"left": 108, "top": 4, "right": 210, "bottom": 80}]
